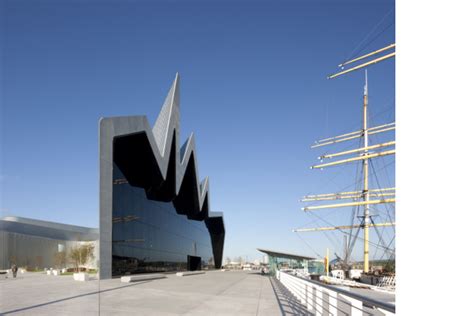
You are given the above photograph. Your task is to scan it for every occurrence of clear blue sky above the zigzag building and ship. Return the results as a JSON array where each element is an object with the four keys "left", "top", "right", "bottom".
[{"left": 0, "top": 0, "right": 395, "bottom": 259}]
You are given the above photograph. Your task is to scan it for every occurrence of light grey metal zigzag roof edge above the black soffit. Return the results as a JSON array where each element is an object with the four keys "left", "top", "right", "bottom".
[{"left": 100, "top": 73, "right": 213, "bottom": 217}]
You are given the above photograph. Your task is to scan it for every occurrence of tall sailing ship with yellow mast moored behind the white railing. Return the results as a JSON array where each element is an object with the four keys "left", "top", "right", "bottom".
[{"left": 293, "top": 43, "right": 395, "bottom": 289}]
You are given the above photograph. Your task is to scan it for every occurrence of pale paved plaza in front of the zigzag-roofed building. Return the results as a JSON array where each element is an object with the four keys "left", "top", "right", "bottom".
[{"left": 0, "top": 271, "right": 307, "bottom": 315}]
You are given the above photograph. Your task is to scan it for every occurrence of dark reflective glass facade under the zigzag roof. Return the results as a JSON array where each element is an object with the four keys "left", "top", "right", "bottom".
[{"left": 112, "top": 164, "right": 214, "bottom": 276}]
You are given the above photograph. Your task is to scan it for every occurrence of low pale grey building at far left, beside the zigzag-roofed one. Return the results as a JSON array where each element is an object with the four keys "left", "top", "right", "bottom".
[{"left": 0, "top": 216, "right": 99, "bottom": 269}]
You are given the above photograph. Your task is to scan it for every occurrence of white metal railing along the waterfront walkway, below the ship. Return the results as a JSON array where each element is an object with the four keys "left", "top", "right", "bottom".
[{"left": 276, "top": 271, "right": 395, "bottom": 316}]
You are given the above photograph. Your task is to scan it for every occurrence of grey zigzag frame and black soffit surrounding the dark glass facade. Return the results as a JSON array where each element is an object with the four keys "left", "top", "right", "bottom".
[{"left": 99, "top": 74, "right": 225, "bottom": 279}]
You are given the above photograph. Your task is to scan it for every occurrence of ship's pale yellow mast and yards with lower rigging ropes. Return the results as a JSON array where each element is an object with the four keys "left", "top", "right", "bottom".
[{"left": 293, "top": 44, "right": 395, "bottom": 273}]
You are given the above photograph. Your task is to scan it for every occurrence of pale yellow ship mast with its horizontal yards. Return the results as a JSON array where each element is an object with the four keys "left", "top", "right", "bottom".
[{"left": 293, "top": 44, "right": 395, "bottom": 273}]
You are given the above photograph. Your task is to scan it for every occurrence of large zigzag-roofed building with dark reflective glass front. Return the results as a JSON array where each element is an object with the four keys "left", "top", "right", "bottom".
[{"left": 99, "top": 75, "right": 225, "bottom": 279}]
